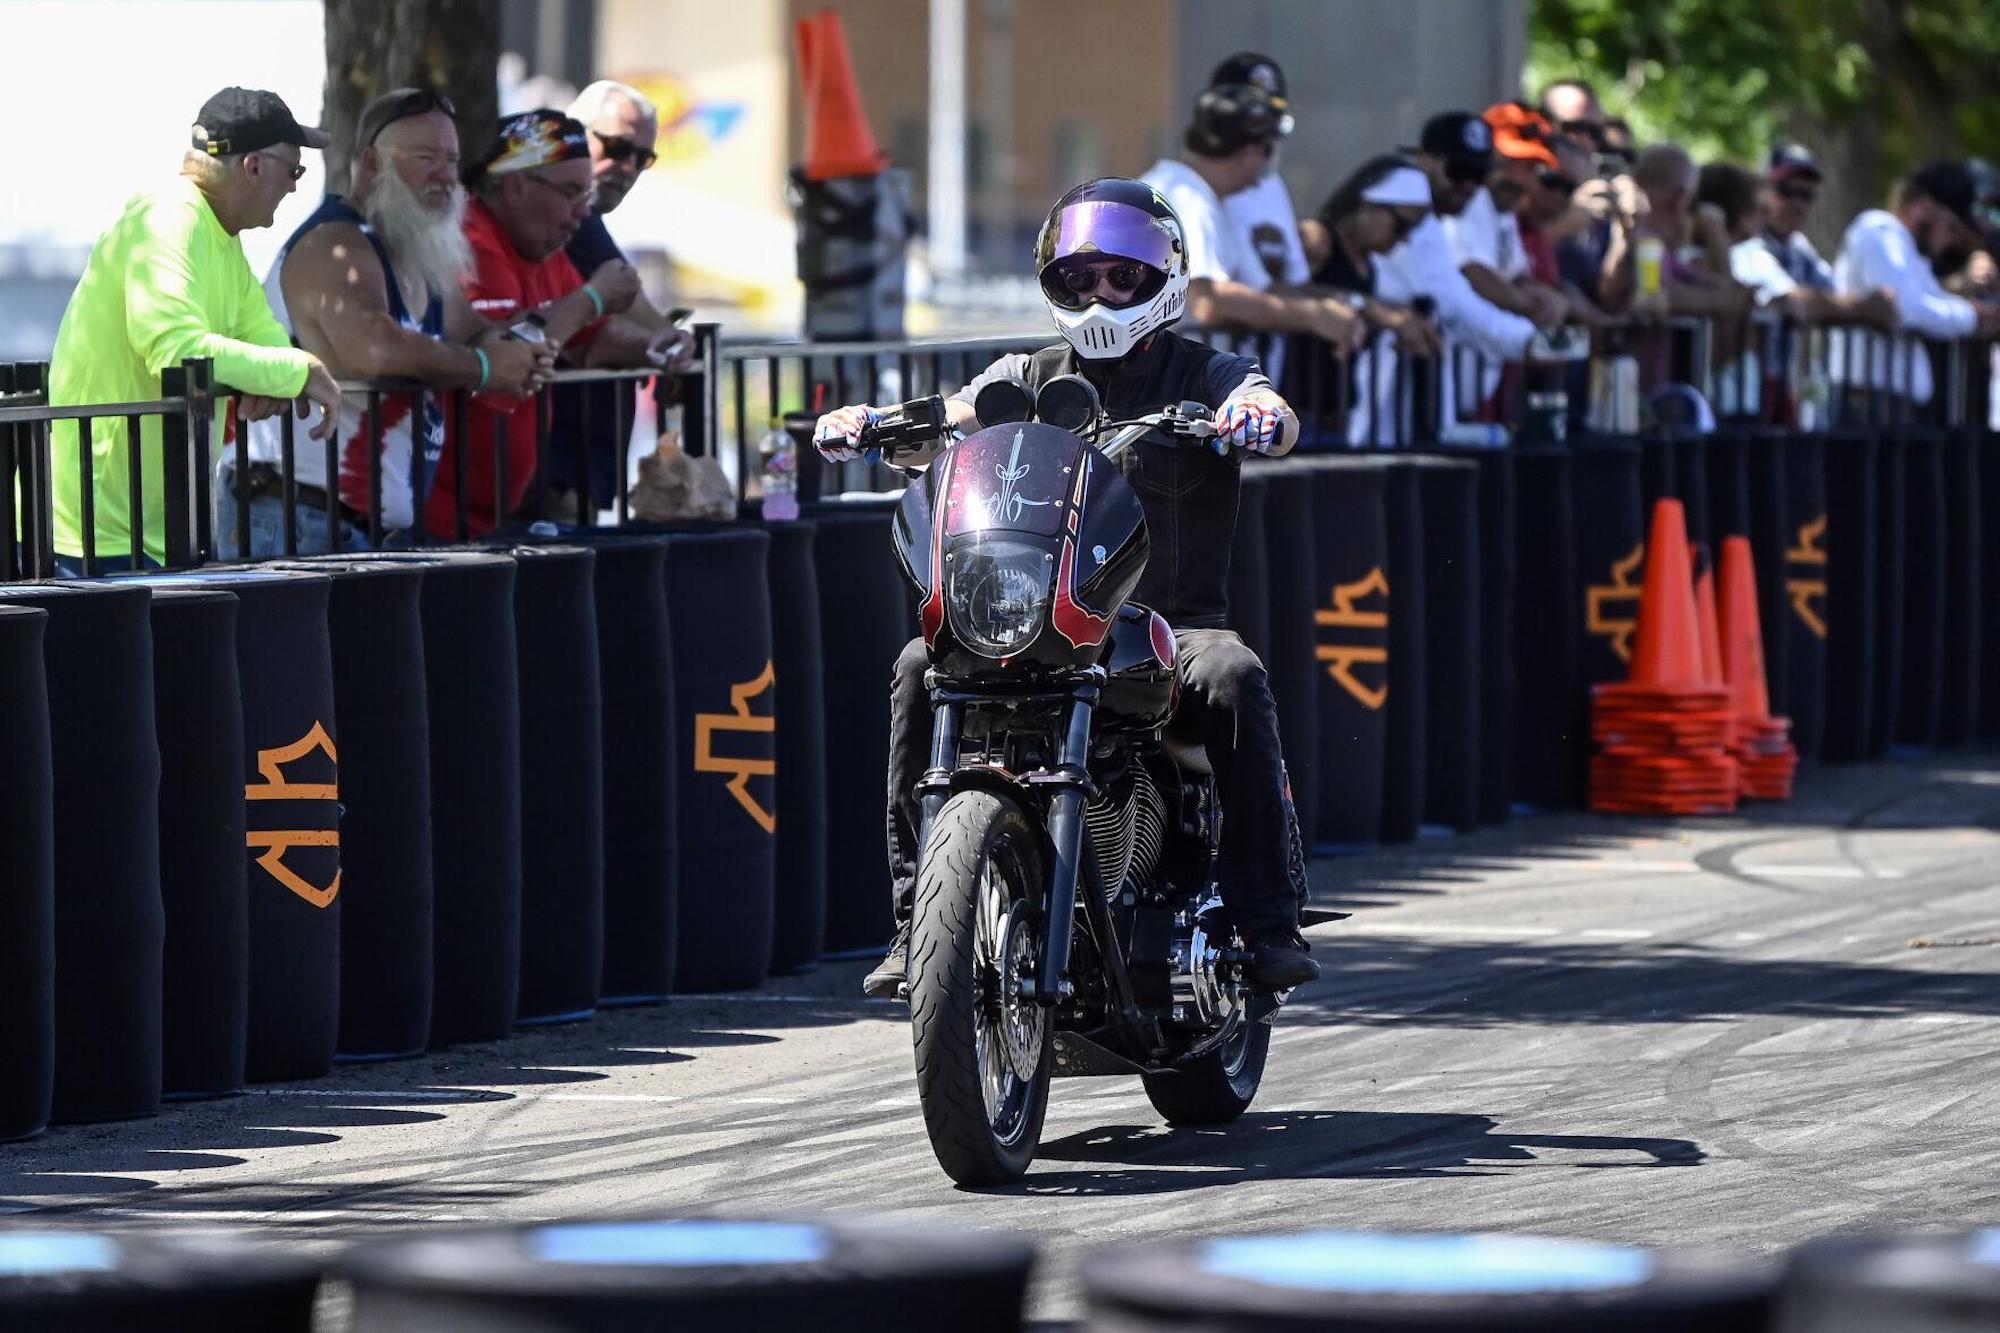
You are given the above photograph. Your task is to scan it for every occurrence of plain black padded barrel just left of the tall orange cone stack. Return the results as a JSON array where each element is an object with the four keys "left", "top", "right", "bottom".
[{"left": 1514, "top": 448, "right": 1588, "bottom": 809}]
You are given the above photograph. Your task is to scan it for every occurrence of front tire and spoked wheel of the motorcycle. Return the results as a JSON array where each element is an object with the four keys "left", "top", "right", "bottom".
[{"left": 908, "top": 791, "right": 1054, "bottom": 1185}]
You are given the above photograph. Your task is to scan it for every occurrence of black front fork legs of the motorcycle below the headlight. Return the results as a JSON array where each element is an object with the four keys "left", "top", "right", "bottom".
[{"left": 916, "top": 667, "right": 1104, "bottom": 1005}]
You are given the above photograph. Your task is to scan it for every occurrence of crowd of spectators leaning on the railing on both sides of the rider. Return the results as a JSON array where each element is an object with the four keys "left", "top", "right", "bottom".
[{"left": 35, "top": 62, "right": 2000, "bottom": 572}]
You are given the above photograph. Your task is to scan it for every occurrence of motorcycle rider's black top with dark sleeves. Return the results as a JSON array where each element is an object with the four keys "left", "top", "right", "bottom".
[{"left": 954, "top": 332, "right": 1270, "bottom": 628}]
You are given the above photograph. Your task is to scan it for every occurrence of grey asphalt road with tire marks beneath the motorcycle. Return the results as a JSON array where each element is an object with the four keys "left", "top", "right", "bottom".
[{"left": 0, "top": 755, "right": 2000, "bottom": 1319}]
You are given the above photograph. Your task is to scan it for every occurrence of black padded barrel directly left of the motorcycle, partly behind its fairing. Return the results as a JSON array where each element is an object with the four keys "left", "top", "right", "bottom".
[{"left": 812, "top": 504, "right": 910, "bottom": 957}]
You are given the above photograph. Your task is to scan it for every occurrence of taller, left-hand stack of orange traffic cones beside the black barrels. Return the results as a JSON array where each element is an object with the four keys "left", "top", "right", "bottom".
[{"left": 1590, "top": 500, "right": 1740, "bottom": 815}]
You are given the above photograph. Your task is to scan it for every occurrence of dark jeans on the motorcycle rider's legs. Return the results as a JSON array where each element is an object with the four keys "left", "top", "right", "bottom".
[{"left": 888, "top": 628, "right": 1306, "bottom": 935}]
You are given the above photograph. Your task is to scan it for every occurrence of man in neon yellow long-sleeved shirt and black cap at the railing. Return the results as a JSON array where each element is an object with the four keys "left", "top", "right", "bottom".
[{"left": 48, "top": 88, "right": 340, "bottom": 574}]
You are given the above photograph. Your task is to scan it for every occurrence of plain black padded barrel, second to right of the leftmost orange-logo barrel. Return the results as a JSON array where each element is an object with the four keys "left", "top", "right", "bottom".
[{"left": 322, "top": 550, "right": 520, "bottom": 1049}]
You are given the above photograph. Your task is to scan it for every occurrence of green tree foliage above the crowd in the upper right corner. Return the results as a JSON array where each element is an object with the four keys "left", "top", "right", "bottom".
[{"left": 1526, "top": 0, "right": 2000, "bottom": 236}]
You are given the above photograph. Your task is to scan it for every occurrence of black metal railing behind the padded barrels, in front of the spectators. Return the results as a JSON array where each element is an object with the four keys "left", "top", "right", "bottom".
[{"left": 0, "top": 316, "right": 1992, "bottom": 580}]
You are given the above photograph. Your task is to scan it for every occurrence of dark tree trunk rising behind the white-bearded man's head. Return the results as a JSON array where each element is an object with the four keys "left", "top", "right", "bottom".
[{"left": 322, "top": 0, "right": 500, "bottom": 192}]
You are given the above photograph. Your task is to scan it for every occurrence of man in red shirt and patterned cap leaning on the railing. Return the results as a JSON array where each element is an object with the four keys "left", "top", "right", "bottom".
[{"left": 424, "top": 110, "right": 652, "bottom": 536}]
